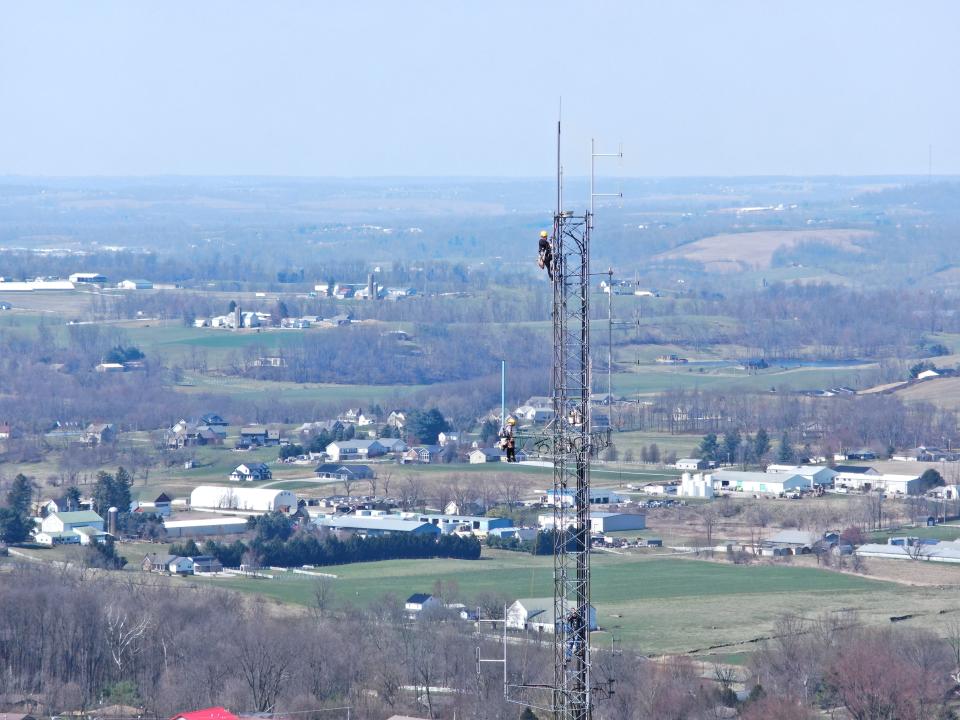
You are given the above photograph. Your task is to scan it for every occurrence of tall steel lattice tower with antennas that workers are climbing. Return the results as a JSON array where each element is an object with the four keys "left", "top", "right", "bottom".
[{"left": 477, "top": 121, "right": 620, "bottom": 720}]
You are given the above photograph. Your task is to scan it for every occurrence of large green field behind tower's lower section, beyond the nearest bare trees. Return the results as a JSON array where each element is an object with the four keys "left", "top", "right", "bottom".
[{"left": 186, "top": 549, "right": 908, "bottom": 653}]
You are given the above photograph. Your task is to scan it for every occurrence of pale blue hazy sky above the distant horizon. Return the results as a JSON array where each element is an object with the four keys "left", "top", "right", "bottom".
[{"left": 0, "top": 0, "right": 960, "bottom": 176}]
